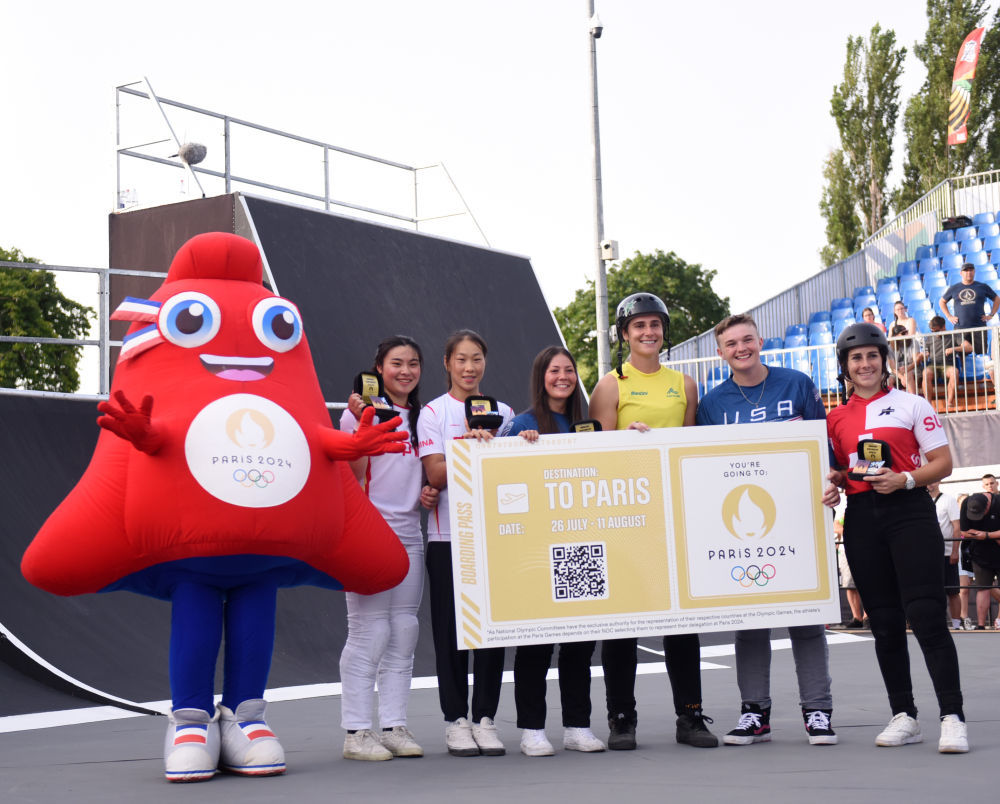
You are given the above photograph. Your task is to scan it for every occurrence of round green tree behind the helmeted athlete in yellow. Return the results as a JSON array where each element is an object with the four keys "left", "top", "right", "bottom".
[{"left": 554, "top": 249, "right": 729, "bottom": 388}]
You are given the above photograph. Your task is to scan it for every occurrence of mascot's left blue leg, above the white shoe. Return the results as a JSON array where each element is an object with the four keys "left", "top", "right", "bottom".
[{"left": 170, "top": 582, "right": 225, "bottom": 713}]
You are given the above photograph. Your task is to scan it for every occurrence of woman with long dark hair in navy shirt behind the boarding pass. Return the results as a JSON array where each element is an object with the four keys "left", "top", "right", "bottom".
[{"left": 502, "top": 346, "right": 605, "bottom": 757}]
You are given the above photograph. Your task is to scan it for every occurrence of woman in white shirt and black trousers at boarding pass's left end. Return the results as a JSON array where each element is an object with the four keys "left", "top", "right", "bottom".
[{"left": 417, "top": 329, "right": 514, "bottom": 757}]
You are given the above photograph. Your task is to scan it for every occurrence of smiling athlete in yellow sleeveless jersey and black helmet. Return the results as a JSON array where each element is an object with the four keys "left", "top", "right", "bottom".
[{"left": 590, "top": 293, "right": 719, "bottom": 751}]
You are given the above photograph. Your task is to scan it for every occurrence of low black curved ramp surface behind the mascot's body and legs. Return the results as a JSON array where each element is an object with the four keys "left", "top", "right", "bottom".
[{"left": 0, "top": 395, "right": 446, "bottom": 716}]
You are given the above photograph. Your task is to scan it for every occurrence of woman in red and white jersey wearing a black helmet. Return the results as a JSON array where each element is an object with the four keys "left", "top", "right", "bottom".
[{"left": 824, "top": 322, "right": 969, "bottom": 753}]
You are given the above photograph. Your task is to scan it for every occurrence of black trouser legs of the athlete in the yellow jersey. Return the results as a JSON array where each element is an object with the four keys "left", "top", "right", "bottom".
[{"left": 601, "top": 634, "right": 701, "bottom": 723}]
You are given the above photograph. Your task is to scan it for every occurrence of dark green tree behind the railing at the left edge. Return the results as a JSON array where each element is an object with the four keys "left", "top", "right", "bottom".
[{"left": 0, "top": 248, "right": 93, "bottom": 392}]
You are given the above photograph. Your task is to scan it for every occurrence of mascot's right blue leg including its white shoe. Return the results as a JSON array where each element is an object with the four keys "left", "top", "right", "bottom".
[{"left": 219, "top": 582, "right": 285, "bottom": 776}]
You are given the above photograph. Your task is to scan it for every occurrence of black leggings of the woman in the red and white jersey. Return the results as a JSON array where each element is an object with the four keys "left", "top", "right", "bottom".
[{"left": 844, "top": 488, "right": 964, "bottom": 719}]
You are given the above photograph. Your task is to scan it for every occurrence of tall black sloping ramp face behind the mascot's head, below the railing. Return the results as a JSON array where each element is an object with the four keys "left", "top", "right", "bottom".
[{"left": 246, "top": 197, "right": 562, "bottom": 411}]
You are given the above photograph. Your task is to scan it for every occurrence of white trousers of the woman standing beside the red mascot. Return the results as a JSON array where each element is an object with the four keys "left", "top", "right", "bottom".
[{"left": 340, "top": 544, "right": 424, "bottom": 729}]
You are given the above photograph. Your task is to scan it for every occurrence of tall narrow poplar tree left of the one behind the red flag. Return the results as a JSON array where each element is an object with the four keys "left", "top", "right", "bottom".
[{"left": 820, "top": 23, "right": 906, "bottom": 265}]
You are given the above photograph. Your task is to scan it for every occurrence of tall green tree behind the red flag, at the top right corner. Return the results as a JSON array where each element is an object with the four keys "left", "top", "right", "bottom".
[{"left": 894, "top": 0, "right": 1000, "bottom": 210}]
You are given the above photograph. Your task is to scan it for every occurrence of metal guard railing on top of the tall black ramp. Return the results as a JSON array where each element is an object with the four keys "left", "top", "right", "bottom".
[{"left": 115, "top": 78, "right": 490, "bottom": 246}]
